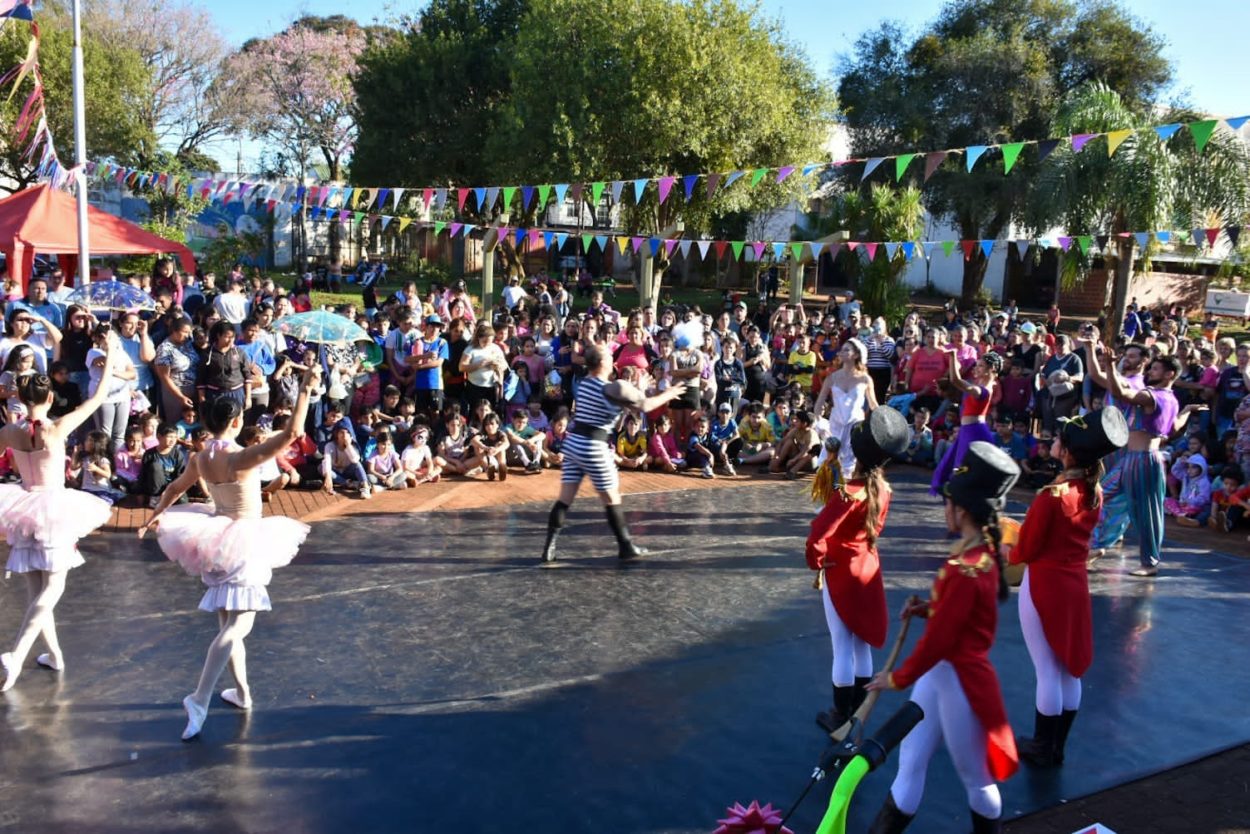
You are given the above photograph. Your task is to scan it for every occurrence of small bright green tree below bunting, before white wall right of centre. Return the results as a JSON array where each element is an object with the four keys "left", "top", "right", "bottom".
[{"left": 795, "top": 184, "right": 924, "bottom": 320}]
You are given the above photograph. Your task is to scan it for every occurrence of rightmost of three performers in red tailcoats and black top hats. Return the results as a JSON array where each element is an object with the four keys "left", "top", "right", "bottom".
[{"left": 1010, "top": 408, "right": 1129, "bottom": 768}]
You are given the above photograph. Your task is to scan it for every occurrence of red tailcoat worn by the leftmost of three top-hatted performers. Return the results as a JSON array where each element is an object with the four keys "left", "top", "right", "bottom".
[{"left": 806, "top": 478, "right": 890, "bottom": 649}]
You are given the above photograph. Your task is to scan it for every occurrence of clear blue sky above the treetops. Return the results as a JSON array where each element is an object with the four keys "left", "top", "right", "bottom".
[{"left": 203, "top": 0, "right": 1250, "bottom": 171}]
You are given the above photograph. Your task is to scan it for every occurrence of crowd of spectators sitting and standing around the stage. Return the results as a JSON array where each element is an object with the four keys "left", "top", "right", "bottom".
[{"left": 0, "top": 260, "right": 1250, "bottom": 529}]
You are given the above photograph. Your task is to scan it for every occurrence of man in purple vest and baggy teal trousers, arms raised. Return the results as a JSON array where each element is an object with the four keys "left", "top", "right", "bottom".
[{"left": 1085, "top": 340, "right": 1205, "bottom": 578}]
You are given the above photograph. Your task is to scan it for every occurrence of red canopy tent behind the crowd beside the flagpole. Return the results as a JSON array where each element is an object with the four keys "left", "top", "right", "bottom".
[{"left": 0, "top": 184, "right": 195, "bottom": 288}]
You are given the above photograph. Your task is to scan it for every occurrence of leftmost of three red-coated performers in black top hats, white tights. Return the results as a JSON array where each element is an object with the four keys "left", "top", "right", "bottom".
[{"left": 808, "top": 406, "right": 908, "bottom": 733}]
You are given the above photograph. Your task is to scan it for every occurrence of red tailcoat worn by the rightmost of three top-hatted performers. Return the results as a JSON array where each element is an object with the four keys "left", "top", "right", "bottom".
[{"left": 1011, "top": 480, "right": 1100, "bottom": 678}]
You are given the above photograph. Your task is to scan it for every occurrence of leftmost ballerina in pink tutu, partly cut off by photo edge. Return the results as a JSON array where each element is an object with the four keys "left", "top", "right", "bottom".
[{"left": 0, "top": 334, "right": 124, "bottom": 691}]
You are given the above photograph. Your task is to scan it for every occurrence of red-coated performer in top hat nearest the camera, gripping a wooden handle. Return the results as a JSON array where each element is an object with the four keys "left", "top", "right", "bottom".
[{"left": 868, "top": 441, "right": 1020, "bottom": 834}]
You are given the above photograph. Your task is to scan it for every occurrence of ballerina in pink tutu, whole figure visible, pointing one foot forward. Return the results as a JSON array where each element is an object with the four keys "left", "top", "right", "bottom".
[{"left": 139, "top": 365, "right": 321, "bottom": 741}]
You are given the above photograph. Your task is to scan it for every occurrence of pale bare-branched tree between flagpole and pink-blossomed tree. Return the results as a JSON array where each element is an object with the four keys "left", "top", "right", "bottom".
[{"left": 69, "top": 0, "right": 241, "bottom": 168}]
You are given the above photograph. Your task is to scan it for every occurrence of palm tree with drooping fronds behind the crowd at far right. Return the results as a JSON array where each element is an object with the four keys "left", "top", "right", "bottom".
[{"left": 1028, "top": 84, "right": 1250, "bottom": 333}]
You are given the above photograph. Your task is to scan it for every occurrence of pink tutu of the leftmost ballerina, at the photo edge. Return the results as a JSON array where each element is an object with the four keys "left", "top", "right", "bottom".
[{"left": 0, "top": 484, "right": 113, "bottom": 574}]
